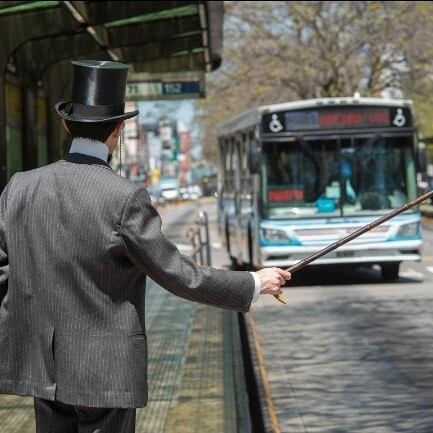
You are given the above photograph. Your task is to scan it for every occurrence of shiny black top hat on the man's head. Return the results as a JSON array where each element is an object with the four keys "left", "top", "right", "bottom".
[{"left": 55, "top": 60, "right": 138, "bottom": 123}]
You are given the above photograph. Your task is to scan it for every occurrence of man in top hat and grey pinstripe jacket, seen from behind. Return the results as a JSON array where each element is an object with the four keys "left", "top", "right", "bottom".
[{"left": 0, "top": 61, "right": 290, "bottom": 433}]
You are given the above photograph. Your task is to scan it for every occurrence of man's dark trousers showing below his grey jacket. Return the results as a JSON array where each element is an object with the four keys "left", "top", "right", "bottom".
[{"left": 34, "top": 398, "right": 135, "bottom": 433}]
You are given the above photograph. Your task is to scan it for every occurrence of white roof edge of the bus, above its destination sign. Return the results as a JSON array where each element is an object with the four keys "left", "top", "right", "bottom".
[{"left": 218, "top": 97, "right": 412, "bottom": 136}]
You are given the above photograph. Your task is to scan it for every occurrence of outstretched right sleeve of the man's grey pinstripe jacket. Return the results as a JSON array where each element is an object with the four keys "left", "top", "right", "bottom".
[{"left": 119, "top": 188, "right": 255, "bottom": 312}]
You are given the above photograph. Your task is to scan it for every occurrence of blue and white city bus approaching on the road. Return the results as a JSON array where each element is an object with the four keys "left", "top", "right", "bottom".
[{"left": 218, "top": 97, "right": 422, "bottom": 280}]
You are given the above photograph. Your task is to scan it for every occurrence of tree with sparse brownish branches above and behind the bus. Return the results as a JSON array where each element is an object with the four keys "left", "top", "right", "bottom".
[{"left": 199, "top": 1, "right": 433, "bottom": 157}]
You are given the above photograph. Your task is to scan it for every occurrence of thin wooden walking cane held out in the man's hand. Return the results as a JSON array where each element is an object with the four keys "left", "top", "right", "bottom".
[{"left": 274, "top": 191, "right": 433, "bottom": 304}]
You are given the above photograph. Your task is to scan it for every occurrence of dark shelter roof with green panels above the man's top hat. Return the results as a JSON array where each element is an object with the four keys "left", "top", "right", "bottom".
[{"left": 0, "top": 1, "right": 224, "bottom": 79}]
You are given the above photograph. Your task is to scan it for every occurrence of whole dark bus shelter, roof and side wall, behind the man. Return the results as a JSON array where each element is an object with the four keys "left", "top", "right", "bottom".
[{"left": 0, "top": 1, "right": 224, "bottom": 188}]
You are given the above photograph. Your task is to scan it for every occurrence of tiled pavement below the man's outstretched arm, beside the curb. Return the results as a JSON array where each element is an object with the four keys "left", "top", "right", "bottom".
[{"left": 137, "top": 278, "right": 248, "bottom": 433}]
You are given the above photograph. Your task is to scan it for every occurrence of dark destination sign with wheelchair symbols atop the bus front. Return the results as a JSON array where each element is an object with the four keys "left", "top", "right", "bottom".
[{"left": 263, "top": 107, "right": 412, "bottom": 133}]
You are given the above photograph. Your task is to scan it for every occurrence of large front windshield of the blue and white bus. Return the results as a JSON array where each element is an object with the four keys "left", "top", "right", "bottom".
[{"left": 262, "top": 135, "right": 416, "bottom": 218}]
